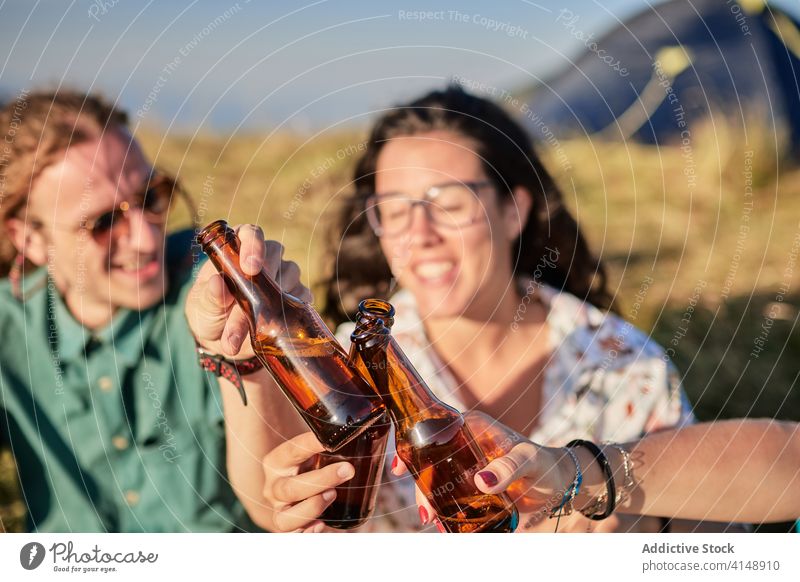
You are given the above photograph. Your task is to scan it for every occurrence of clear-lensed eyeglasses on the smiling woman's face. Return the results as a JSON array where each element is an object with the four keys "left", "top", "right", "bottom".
[{"left": 366, "top": 181, "right": 493, "bottom": 236}]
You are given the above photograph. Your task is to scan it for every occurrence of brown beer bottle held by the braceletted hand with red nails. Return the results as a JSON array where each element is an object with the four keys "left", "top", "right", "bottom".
[{"left": 351, "top": 299, "right": 519, "bottom": 533}]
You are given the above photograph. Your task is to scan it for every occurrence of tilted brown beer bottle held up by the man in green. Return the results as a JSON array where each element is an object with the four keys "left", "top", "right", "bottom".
[{"left": 197, "top": 220, "right": 385, "bottom": 451}]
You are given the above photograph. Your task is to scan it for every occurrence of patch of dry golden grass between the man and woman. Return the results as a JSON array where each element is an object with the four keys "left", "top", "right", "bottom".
[{"left": 141, "top": 126, "right": 363, "bottom": 288}]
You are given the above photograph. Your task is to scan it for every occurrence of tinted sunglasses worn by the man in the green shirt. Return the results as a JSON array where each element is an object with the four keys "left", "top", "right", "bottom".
[{"left": 31, "top": 173, "right": 178, "bottom": 245}]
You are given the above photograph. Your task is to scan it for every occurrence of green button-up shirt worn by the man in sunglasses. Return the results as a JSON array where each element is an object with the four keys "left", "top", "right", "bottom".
[{"left": 0, "top": 233, "right": 252, "bottom": 532}]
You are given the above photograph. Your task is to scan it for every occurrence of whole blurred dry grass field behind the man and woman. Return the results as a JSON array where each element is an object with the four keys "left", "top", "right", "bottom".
[{"left": 0, "top": 122, "right": 800, "bottom": 530}]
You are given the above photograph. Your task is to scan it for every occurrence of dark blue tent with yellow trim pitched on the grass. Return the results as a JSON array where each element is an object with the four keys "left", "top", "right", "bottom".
[{"left": 526, "top": 0, "right": 800, "bottom": 151}]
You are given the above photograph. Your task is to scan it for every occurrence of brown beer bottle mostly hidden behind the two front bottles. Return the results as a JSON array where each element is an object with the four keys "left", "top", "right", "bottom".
[{"left": 314, "top": 309, "right": 394, "bottom": 529}]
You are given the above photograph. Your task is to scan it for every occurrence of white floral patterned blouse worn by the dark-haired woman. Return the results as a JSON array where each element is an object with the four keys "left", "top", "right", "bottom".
[{"left": 336, "top": 285, "right": 694, "bottom": 532}]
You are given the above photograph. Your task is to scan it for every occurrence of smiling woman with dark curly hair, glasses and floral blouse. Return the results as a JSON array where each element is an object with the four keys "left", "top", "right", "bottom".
[{"left": 258, "top": 87, "right": 691, "bottom": 531}]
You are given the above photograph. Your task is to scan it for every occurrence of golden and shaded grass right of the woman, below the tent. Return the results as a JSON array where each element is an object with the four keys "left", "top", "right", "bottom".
[{"left": 554, "top": 127, "right": 800, "bottom": 421}]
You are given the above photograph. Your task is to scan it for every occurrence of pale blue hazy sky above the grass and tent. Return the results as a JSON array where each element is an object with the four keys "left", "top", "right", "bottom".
[{"left": 0, "top": 0, "right": 800, "bottom": 131}]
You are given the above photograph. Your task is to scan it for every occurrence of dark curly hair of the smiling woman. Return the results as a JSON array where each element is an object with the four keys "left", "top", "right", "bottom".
[{"left": 322, "top": 85, "right": 612, "bottom": 325}]
